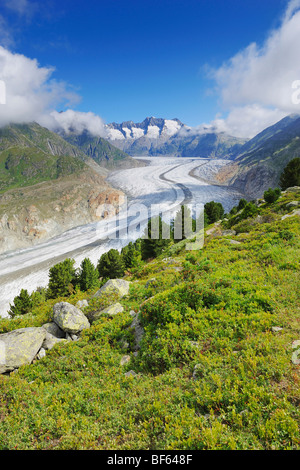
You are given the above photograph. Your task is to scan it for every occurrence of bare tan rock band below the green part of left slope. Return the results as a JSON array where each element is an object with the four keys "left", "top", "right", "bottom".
[{"left": 0, "top": 167, "right": 124, "bottom": 253}]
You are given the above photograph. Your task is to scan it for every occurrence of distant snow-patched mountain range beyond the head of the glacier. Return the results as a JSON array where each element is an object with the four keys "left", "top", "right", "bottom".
[{"left": 106, "top": 117, "right": 246, "bottom": 158}]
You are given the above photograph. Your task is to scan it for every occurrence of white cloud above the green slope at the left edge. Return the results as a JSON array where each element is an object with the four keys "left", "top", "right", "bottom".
[{"left": 0, "top": 46, "right": 79, "bottom": 126}]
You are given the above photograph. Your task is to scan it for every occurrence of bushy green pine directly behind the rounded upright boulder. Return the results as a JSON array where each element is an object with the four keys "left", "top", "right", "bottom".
[{"left": 47, "top": 258, "right": 76, "bottom": 299}]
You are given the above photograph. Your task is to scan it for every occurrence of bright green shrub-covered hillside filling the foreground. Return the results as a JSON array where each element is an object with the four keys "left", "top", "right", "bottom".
[{"left": 0, "top": 192, "right": 300, "bottom": 450}]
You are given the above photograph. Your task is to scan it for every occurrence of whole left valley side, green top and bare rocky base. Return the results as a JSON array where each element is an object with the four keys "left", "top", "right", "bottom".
[{"left": 0, "top": 123, "right": 124, "bottom": 253}]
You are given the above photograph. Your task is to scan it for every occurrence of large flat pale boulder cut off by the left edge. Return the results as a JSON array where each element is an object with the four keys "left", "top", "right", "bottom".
[{"left": 0, "top": 327, "right": 46, "bottom": 374}]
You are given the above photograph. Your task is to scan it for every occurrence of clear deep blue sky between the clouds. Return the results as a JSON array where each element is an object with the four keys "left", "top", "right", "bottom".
[{"left": 0, "top": 0, "right": 300, "bottom": 136}]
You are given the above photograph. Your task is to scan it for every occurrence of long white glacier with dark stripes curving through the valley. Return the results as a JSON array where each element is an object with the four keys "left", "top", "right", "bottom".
[{"left": 0, "top": 156, "right": 242, "bottom": 316}]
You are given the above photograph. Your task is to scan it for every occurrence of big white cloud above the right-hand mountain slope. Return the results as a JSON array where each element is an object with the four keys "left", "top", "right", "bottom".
[{"left": 213, "top": 0, "right": 300, "bottom": 137}]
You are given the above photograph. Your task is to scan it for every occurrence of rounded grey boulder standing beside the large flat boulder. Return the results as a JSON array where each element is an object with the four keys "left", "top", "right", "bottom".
[{"left": 53, "top": 302, "right": 90, "bottom": 335}]
